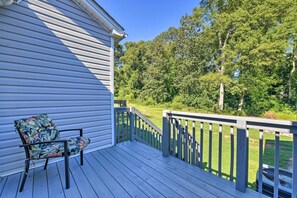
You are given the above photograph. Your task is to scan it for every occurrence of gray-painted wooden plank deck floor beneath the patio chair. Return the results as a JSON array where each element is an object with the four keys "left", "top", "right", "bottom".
[{"left": 0, "top": 142, "right": 261, "bottom": 198}]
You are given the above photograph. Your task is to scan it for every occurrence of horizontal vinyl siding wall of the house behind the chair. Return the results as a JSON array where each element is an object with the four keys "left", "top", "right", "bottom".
[{"left": 0, "top": 0, "right": 113, "bottom": 176}]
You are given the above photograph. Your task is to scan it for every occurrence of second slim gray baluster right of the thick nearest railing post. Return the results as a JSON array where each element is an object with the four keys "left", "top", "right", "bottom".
[{"left": 273, "top": 132, "right": 279, "bottom": 198}]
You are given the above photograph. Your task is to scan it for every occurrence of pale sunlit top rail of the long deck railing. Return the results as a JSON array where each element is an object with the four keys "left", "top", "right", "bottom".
[{"left": 164, "top": 110, "right": 297, "bottom": 134}]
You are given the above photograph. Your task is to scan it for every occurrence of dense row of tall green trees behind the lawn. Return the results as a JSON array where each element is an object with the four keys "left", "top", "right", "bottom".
[{"left": 115, "top": 0, "right": 297, "bottom": 115}]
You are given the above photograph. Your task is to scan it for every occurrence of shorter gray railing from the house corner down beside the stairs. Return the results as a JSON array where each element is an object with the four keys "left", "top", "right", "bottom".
[{"left": 114, "top": 107, "right": 162, "bottom": 150}]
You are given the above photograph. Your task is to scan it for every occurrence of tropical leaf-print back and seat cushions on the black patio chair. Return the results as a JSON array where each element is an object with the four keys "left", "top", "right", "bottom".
[{"left": 14, "top": 114, "right": 90, "bottom": 159}]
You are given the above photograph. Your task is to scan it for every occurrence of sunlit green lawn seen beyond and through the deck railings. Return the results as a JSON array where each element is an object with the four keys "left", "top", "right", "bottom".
[{"left": 123, "top": 103, "right": 292, "bottom": 188}]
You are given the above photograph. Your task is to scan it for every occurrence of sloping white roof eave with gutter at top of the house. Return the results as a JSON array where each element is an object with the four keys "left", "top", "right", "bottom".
[{"left": 73, "top": 0, "right": 127, "bottom": 40}]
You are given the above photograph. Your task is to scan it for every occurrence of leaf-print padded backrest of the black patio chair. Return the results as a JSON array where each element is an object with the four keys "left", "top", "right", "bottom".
[{"left": 14, "top": 114, "right": 60, "bottom": 144}]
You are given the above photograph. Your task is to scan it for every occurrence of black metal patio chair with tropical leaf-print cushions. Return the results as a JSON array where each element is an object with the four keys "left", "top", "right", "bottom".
[{"left": 14, "top": 114, "right": 90, "bottom": 192}]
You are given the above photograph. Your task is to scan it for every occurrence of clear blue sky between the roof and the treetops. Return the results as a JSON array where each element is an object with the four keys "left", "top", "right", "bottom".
[{"left": 97, "top": 0, "right": 199, "bottom": 42}]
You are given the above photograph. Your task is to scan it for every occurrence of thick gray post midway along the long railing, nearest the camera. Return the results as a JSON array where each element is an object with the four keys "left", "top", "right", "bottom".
[{"left": 236, "top": 120, "right": 248, "bottom": 192}]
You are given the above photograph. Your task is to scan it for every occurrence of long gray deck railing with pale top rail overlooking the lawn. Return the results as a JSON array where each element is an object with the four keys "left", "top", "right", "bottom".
[{"left": 162, "top": 111, "right": 297, "bottom": 198}]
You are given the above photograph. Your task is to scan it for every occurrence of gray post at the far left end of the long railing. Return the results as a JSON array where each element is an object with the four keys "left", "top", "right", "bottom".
[{"left": 162, "top": 111, "right": 170, "bottom": 157}]
